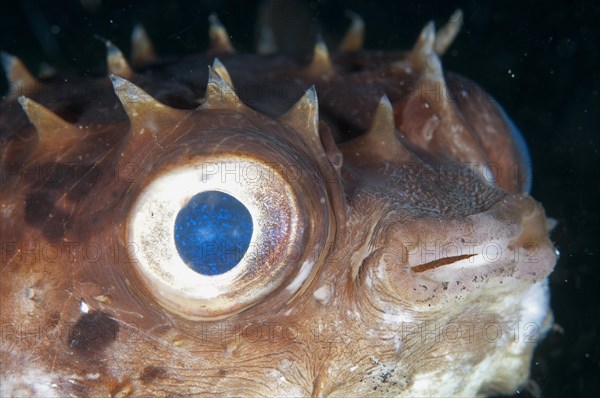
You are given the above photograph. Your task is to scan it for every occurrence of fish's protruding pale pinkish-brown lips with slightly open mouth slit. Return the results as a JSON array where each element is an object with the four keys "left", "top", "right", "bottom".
[{"left": 368, "top": 194, "right": 558, "bottom": 308}]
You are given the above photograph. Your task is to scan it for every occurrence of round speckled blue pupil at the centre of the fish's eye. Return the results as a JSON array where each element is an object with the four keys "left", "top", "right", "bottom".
[{"left": 175, "top": 191, "right": 253, "bottom": 275}]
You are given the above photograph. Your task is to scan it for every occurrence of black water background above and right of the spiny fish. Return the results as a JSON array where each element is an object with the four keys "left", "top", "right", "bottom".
[{"left": 0, "top": 0, "right": 600, "bottom": 397}]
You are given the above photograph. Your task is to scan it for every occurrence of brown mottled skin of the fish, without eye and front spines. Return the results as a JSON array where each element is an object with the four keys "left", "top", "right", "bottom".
[{"left": 0, "top": 15, "right": 556, "bottom": 397}]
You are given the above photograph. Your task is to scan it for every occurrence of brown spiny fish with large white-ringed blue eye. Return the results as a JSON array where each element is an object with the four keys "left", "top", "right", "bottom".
[{"left": 0, "top": 7, "right": 557, "bottom": 397}]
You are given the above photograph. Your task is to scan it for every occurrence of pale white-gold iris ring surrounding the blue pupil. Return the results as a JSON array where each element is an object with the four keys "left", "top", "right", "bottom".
[{"left": 129, "top": 156, "right": 301, "bottom": 319}]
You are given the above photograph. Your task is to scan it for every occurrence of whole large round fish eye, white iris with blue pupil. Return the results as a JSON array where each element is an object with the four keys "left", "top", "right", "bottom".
[{"left": 128, "top": 155, "right": 323, "bottom": 320}]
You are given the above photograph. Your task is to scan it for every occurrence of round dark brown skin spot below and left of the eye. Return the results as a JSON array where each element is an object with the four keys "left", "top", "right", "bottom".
[{"left": 69, "top": 311, "right": 119, "bottom": 354}]
